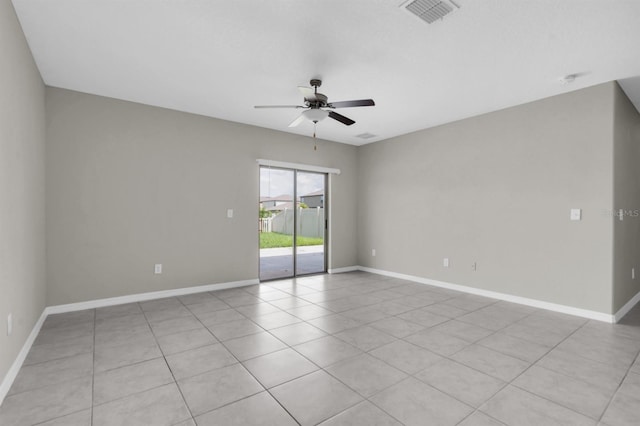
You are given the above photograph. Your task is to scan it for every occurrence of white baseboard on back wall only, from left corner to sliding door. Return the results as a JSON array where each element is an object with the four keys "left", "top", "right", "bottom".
[{"left": 45, "top": 278, "right": 260, "bottom": 315}]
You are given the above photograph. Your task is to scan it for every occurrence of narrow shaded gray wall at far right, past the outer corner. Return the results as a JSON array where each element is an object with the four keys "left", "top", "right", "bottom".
[{"left": 613, "top": 84, "right": 640, "bottom": 311}]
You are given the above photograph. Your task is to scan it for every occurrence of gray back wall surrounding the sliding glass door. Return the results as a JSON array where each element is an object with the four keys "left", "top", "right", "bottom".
[{"left": 46, "top": 88, "right": 356, "bottom": 305}]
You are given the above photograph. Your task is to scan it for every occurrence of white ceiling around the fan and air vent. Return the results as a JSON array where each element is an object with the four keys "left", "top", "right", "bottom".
[{"left": 13, "top": 0, "right": 640, "bottom": 145}]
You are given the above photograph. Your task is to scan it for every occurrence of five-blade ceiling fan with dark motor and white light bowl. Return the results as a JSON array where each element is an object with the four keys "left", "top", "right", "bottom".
[{"left": 254, "top": 78, "right": 375, "bottom": 127}]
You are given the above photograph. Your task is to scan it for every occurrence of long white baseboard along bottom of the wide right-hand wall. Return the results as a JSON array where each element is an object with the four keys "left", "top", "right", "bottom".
[{"left": 358, "top": 266, "right": 616, "bottom": 323}]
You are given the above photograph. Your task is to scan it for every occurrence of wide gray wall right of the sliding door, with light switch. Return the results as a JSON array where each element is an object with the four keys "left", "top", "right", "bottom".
[{"left": 357, "top": 83, "right": 616, "bottom": 313}]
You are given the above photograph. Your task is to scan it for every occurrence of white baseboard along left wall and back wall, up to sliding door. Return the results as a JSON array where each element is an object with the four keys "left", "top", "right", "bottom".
[{"left": 0, "top": 278, "right": 260, "bottom": 405}]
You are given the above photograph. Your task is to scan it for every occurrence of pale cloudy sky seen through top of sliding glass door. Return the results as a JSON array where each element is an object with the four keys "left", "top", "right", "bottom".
[{"left": 260, "top": 167, "right": 325, "bottom": 197}]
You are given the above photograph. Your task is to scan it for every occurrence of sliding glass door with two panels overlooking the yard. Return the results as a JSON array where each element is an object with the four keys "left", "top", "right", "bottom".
[{"left": 258, "top": 166, "right": 327, "bottom": 281}]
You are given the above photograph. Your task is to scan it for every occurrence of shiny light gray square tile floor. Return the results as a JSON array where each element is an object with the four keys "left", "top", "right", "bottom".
[{"left": 0, "top": 272, "right": 640, "bottom": 426}]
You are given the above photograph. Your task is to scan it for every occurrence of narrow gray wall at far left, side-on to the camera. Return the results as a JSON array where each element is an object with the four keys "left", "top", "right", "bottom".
[{"left": 0, "top": 0, "right": 46, "bottom": 381}]
